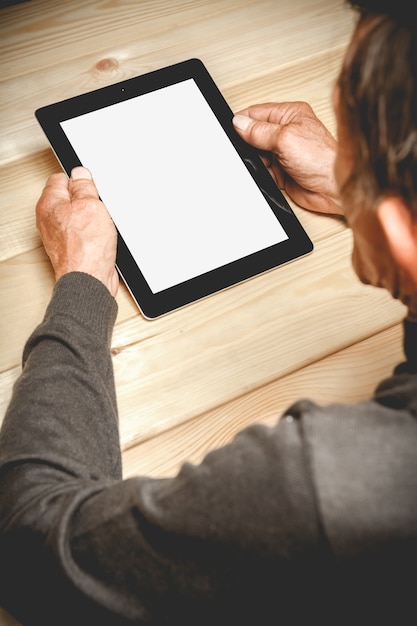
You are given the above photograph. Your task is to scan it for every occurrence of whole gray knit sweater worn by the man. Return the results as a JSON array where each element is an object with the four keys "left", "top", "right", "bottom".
[{"left": 0, "top": 273, "right": 417, "bottom": 626}]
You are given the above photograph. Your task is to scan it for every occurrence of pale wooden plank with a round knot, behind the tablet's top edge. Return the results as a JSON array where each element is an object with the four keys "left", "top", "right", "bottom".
[{"left": 0, "top": 0, "right": 351, "bottom": 165}]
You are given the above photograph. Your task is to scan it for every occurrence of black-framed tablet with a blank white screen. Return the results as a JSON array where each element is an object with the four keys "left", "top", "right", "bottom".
[{"left": 35, "top": 59, "right": 313, "bottom": 319}]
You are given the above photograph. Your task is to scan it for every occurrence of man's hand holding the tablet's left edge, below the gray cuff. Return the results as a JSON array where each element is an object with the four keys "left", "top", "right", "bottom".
[{"left": 36, "top": 167, "right": 119, "bottom": 296}]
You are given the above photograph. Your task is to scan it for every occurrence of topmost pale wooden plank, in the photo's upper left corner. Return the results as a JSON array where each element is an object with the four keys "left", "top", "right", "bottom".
[{"left": 0, "top": 0, "right": 254, "bottom": 79}]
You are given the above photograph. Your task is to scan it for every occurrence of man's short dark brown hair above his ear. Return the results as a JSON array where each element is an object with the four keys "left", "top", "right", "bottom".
[{"left": 338, "top": 6, "right": 417, "bottom": 218}]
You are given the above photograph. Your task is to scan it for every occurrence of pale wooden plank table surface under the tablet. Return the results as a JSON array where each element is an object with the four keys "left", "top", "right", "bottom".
[{"left": 0, "top": 0, "right": 404, "bottom": 626}]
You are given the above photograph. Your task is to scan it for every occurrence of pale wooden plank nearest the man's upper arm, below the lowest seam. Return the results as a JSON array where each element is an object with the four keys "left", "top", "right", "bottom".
[{"left": 122, "top": 324, "right": 404, "bottom": 478}]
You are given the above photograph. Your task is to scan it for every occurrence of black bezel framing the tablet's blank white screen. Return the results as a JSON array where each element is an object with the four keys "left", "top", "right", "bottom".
[{"left": 35, "top": 59, "right": 313, "bottom": 319}]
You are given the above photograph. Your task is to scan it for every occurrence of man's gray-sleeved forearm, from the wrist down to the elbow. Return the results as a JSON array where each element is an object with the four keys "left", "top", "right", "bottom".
[{"left": 0, "top": 273, "right": 120, "bottom": 490}]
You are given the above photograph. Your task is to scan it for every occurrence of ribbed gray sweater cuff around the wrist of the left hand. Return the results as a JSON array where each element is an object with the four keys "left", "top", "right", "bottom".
[{"left": 44, "top": 272, "right": 118, "bottom": 345}]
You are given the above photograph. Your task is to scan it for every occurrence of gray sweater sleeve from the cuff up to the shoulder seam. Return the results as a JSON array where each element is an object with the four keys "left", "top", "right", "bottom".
[{"left": 0, "top": 273, "right": 325, "bottom": 626}]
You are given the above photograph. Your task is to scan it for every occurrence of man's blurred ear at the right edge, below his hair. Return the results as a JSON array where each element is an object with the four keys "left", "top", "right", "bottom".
[{"left": 377, "top": 197, "right": 417, "bottom": 285}]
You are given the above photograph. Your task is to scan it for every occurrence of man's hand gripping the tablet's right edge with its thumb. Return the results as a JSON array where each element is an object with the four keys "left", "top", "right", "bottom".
[{"left": 233, "top": 102, "right": 343, "bottom": 215}]
